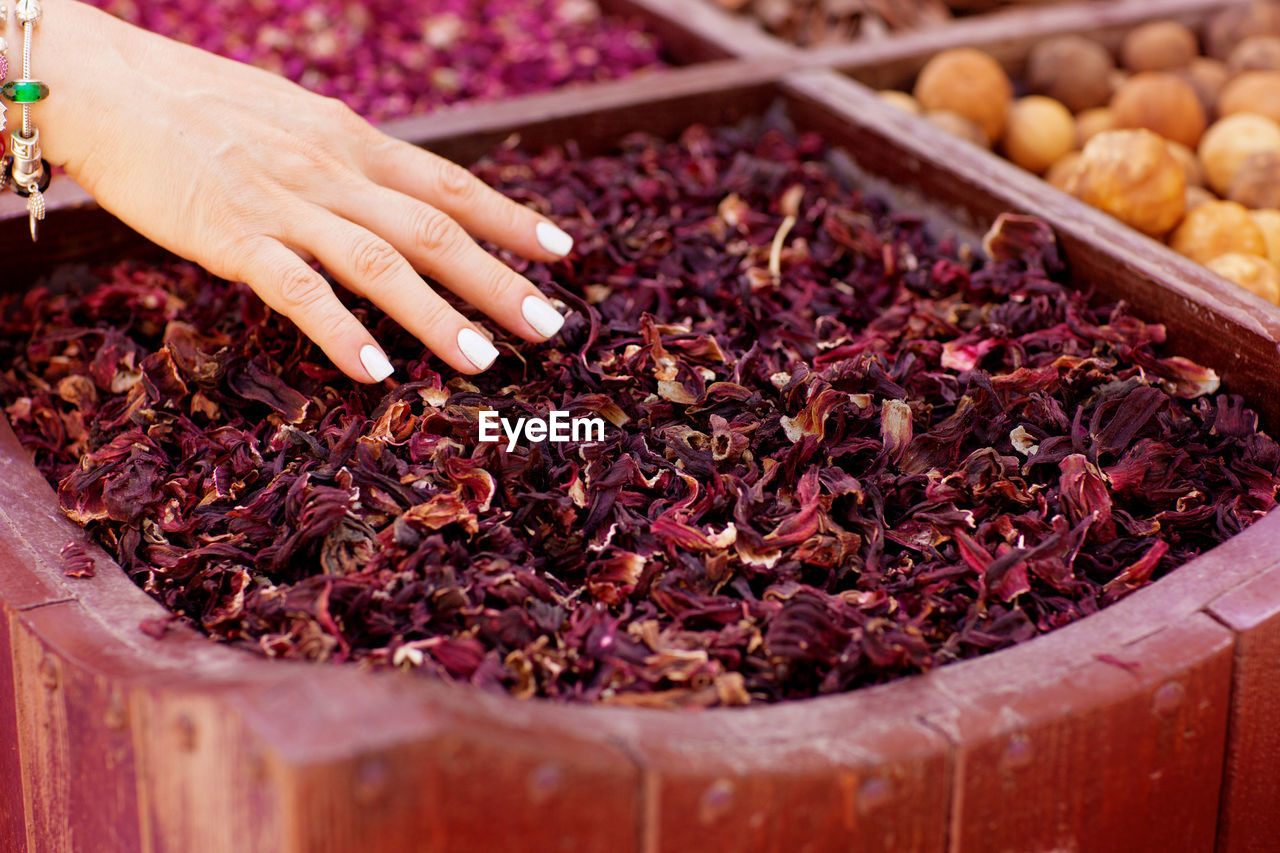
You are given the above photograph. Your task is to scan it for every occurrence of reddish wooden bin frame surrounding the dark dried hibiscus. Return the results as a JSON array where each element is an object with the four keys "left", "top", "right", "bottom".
[{"left": 0, "top": 43, "right": 1280, "bottom": 850}]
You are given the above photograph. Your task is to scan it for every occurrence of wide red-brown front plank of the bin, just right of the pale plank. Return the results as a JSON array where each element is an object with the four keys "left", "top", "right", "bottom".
[{"left": 230, "top": 667, "right": 640, "bottom": 853}]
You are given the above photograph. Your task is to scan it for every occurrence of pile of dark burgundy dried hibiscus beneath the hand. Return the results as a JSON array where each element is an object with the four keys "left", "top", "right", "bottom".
[{"left": 0, "top": 124, "right": 1280, "bottom": 706}]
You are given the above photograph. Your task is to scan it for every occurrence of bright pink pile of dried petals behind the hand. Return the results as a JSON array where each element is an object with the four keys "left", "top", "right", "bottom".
[{"left": 81, "top": 0, "right": 664, "bottom": 120}]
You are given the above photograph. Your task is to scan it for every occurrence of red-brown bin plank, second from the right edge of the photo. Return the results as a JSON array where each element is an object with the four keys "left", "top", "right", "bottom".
[{"left": 929, "top": 613, "right": 1233, "bottom": 853}]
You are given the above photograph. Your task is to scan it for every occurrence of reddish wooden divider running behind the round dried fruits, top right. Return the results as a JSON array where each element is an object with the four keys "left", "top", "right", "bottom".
[{"left": 805, "top": 0, "right": 1249, "bottom": 88}]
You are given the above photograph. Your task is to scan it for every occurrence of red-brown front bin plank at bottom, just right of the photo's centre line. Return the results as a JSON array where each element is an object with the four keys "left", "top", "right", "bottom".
[{"left": 614, "top": 680, "right": 952, "bottom": 853}]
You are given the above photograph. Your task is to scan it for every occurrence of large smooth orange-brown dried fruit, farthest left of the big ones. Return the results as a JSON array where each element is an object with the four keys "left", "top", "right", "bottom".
[{"left": 914, "top": 47, "right": 1014, "bottom": 143}]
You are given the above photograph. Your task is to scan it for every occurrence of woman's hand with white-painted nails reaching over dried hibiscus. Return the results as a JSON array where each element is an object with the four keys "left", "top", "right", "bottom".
[{"left": 31, "top": 0, "right": 573, "bottom": 382}]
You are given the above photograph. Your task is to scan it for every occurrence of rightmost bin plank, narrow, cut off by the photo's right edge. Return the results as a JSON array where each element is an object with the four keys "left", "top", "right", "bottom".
[{"left": 1208, "top": 567, "right": 1280, "bottom": 853}]
